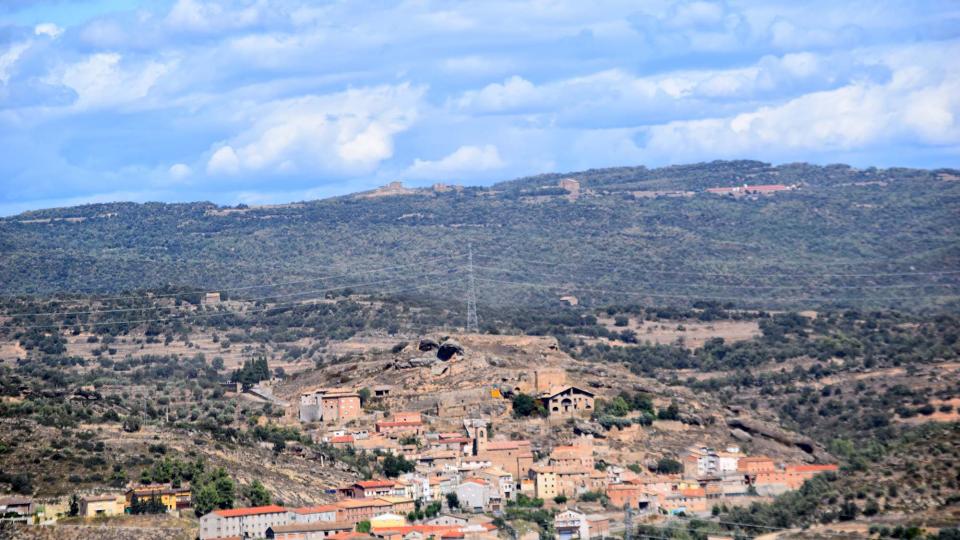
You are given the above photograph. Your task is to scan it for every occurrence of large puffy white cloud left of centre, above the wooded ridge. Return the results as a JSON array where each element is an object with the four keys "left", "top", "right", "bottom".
[{"left": 207, "top": 84, "right": 424, "bottom": 174}]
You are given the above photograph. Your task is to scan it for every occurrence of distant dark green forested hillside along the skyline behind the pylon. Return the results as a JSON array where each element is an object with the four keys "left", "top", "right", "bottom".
[{"left": 0, "top": 161, "right": 960, "bottom": 308}]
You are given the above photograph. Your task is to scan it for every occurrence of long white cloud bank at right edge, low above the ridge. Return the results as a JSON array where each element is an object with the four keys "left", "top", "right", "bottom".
[{"left": 644, "top": 69, "right": 960, "bottom": 161}]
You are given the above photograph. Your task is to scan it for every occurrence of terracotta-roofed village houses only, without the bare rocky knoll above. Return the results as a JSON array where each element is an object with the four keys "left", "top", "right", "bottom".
[{"left": 0, "top": 358, "right": 837, "bottom": 540}]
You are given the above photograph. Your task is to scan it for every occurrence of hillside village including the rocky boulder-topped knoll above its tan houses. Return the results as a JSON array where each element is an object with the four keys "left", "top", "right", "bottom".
[{"left": 0, "top": 338, "right": 838, "bottom": 540}]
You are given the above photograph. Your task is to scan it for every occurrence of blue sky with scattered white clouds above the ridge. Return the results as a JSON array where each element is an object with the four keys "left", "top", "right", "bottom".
[{"left": 0, "top": 0, "right": 960, "bottom": 215}]
